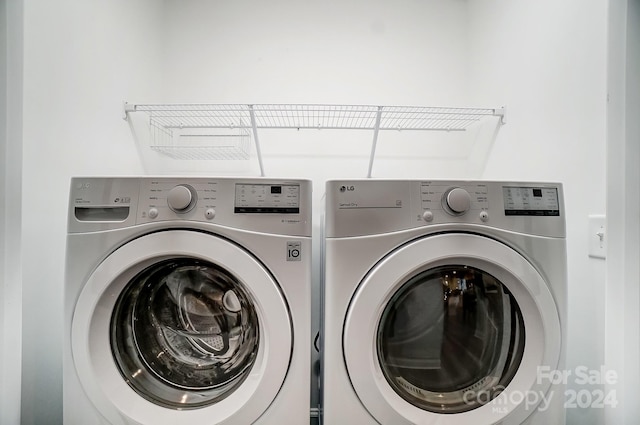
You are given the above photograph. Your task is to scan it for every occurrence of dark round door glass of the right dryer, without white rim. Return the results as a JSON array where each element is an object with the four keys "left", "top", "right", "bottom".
[{"left": 377, "top": 265, "right": 525, "bottom": 413}]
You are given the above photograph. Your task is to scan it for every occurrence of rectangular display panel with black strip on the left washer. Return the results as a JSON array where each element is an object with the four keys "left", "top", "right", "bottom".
[{"left": 234, "top": 183, "right": 300, "bottom": 214}]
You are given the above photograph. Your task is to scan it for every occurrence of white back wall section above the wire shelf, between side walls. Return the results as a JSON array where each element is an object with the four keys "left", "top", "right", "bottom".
[{"left": 163, "top": 0, "right": 467, "bottom": 105}]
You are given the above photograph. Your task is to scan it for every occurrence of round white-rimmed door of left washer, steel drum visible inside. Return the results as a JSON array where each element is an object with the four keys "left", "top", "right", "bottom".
[{"left": 71, "top": 230, "right": 293, "bottom": 425}]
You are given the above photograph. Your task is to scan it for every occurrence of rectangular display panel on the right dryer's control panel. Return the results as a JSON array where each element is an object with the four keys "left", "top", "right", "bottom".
[{"left": 502, "top": 186, "right": 560, "bottom": 216}]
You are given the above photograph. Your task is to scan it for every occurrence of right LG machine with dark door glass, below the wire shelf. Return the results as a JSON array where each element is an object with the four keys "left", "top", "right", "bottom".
[{"left": 321, "top": 180, "right": 567, "bottom": 425}]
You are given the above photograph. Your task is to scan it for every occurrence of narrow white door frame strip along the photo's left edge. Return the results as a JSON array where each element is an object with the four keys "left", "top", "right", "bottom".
[{"left": 0, "top": 1, "right": 22, "bottom": 424}]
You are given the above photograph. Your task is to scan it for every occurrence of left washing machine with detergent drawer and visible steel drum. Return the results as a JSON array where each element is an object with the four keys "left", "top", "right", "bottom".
[{"left": 63, "top": 177, "right": 311, "bottom": 425}]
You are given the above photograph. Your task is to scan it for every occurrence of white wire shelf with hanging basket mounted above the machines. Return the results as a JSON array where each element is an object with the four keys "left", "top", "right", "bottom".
[{"left": 124, "top": 103, "right": 506, "bottom": 177}]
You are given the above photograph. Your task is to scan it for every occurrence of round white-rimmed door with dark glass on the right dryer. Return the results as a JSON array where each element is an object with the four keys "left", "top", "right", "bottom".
[{"left": 343, "top": 233, "right": 561, "bottom": 425}]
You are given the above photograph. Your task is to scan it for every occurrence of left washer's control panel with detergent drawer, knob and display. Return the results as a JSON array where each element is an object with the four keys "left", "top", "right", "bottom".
[{"left": 69, "top": 177, "right": 312, "bottom": 235}]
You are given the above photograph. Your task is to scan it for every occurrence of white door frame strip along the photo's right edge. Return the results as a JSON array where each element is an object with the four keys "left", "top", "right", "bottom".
[{"left": 606, "top": 0, "right": 640, "bottom": 424}]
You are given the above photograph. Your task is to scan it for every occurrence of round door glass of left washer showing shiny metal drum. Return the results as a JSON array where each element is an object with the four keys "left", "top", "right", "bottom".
[{"left": 111, "top": 258, "right": 260, "bottom": 409}]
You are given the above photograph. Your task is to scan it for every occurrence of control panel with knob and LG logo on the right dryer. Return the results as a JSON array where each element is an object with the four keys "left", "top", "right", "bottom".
[{"left": 325, "top": 179, "right": 565, "bottom": 237}]
